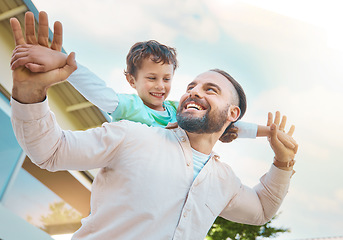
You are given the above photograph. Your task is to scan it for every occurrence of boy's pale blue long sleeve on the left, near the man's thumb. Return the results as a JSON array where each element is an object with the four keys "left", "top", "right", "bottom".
[{"left": 67, "top": 63, "right": 119, "bottom": 113}]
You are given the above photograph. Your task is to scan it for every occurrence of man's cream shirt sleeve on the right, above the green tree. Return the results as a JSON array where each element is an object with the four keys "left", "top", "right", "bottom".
[{"left": 220, "top": 165, "right": 293, "bottom": 225}]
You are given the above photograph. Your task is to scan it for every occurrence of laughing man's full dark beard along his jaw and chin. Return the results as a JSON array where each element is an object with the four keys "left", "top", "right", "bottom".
[{"left": 176, "top": 103, "right": 229, "bottom": 133}]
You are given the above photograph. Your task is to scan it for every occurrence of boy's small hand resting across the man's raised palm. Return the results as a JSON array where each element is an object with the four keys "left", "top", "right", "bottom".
[{"left": 11, "top": 44, "right": 68, "bottom": 72}]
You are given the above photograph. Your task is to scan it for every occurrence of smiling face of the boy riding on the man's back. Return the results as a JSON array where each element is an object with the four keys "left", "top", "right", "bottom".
[{"left": 126, "top": 58, "right": 174, "bottom": 111}]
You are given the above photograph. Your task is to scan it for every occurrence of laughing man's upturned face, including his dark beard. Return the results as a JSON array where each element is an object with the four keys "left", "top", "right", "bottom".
[{"left": 177, "top": 71, "right": 239, "bottom": 133}]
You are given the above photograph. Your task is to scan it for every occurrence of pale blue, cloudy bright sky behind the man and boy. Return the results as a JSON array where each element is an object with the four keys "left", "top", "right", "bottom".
[{"left": 33, "top": 0, "right": 343, "bottom": 239}]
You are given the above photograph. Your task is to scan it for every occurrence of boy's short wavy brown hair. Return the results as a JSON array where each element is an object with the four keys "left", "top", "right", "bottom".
[{"left": 124, "top": 40, "right": 178, "bottom": 77}]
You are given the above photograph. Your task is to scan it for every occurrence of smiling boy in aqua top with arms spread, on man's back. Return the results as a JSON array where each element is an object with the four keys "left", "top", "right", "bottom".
[{"left": 11, "top": 40, "right": 278, "bottom": 142}]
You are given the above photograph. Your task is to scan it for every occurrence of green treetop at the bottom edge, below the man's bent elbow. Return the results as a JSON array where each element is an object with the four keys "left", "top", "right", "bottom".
[{"left": 206, "top": 215, "right": 290, "bottom": 240}]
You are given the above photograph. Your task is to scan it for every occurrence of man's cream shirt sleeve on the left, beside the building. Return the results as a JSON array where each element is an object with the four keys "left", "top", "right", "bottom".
[{"left": 11, "top": 96, "right": 128, "bottom": 171}]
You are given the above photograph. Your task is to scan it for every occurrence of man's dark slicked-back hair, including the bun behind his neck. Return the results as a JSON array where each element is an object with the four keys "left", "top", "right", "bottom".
[{"left": 210, "top": 69, "right": 247, "bottom": 142}]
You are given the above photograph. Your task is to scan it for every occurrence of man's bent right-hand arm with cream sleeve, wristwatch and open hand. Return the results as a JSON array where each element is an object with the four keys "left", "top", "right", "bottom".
[{"left": 220, "top": 112, "right": 298, "bottom": 225}]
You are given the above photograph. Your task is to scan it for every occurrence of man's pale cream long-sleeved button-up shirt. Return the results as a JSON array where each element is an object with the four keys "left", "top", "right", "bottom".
[{"left": 12, "top": 99, "right": 292, "bottom": 240}]
